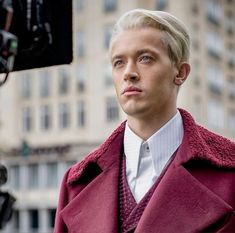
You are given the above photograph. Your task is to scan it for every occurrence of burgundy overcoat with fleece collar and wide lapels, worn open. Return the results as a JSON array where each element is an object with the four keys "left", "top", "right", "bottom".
[{"left": 54, "top": 109, "right": 235, "bottom": 233}]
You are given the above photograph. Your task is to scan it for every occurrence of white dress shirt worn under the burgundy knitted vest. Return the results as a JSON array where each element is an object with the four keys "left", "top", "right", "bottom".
[{"left": 124, "top": 111, "right": 184, "bottom": 203}]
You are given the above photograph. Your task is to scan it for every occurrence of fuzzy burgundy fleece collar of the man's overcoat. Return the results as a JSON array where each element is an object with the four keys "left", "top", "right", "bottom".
[{"left": 68, "top": 109, "right": 235, "bottom": 184}]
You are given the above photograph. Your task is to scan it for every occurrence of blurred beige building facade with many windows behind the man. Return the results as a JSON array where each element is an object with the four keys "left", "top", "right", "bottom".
[{"left": 0, "top": 0, "right": 235, "bottom": 233}]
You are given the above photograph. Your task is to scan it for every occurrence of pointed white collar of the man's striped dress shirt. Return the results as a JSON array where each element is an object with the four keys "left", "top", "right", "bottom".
[{"left": 124, "top": 110, "right": 184, "bottom": 176}]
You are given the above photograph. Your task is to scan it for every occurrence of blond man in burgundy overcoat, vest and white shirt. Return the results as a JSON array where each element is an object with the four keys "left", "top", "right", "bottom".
[{"left": 54, "top": 9, "right": 235, "bottom": 233}]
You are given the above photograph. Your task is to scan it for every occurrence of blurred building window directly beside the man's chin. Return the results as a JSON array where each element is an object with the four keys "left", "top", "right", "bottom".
[{"left": 106, "top": 97, "right": 119, "bottom": 122}]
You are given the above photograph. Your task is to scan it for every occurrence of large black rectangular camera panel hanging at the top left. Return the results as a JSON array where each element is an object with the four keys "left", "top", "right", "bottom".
[{"left": 10, "top": 0, "right": 72, "bottom": 71}]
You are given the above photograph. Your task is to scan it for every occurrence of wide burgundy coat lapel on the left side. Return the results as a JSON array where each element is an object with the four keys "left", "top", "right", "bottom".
[{"left": 61, "top": 128, "right": 123, "bottom": 233}]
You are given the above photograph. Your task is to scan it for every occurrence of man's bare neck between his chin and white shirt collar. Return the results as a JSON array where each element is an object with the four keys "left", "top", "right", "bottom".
[{"left": 127, "top": 109, "right": 177, "bottom": 141}]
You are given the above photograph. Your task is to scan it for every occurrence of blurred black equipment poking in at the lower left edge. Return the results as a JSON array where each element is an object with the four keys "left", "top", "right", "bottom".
[{"left": 0, "top": 164, "right": 16, "bottom": 229}]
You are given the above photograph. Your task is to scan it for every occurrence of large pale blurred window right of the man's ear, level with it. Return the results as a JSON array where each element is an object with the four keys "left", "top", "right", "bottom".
[{"left": 207, "top": 65, "right": 224, "bottom": 94}]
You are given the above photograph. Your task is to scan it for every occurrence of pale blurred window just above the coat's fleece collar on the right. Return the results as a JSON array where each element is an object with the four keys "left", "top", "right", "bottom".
[{"left": 208, "top": 100, "right": 224, "bottom": 129}]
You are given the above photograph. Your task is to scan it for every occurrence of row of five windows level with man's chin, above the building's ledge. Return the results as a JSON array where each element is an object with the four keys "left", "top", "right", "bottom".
[{"left": 21, "top": 97, "right": 119, "bottom": 132}]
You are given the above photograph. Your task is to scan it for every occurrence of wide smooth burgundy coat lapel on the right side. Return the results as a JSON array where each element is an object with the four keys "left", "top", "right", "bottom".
[{"left": 135, "top": 166, "right": 233, "bottom": 233}]
